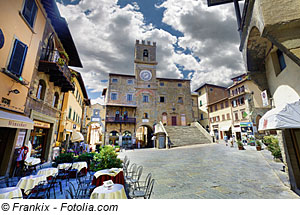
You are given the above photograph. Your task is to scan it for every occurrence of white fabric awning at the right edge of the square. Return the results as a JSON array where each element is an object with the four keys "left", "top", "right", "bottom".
[{"left": 258, "top": 101, "right": 300, "bottom": 131}]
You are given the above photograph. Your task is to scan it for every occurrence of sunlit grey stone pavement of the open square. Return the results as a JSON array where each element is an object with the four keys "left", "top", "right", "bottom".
[{"left": 119, "top": 144, "right": 299, "bottom": 199}]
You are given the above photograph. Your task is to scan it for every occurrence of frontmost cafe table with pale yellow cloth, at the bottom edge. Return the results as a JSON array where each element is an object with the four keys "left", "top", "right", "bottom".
[{"left": 91, "top": 184, "right": 127, "bottom": 199}]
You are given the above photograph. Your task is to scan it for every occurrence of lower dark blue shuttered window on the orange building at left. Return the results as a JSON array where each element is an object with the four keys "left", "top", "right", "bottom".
[{"left": 7, "top": 39, "right": 27, "bottom": 76}]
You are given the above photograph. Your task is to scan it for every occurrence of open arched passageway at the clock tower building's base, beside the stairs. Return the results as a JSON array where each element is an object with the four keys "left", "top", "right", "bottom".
[{"left": 136, "top": 125, "right": 153, "bottom": 148}]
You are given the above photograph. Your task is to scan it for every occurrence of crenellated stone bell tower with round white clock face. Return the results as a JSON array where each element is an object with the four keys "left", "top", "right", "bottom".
[{"left": 134, "top": 40, "right": 157, "bottom": 85}]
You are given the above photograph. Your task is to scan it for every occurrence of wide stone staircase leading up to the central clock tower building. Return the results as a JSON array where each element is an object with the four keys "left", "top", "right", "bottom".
[{"left": 165, "top": 126, "right": 211, "bottom": 147}]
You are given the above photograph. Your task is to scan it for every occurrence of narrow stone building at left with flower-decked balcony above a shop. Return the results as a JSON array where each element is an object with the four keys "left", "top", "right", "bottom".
[{"left": 25, "top": 0, "right": 81, "bottom": 161}]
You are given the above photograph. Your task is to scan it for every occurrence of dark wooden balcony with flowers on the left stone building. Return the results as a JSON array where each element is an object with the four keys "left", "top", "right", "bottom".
[{"left": 38, "top": 49, "right": 75, "bottom": 92}]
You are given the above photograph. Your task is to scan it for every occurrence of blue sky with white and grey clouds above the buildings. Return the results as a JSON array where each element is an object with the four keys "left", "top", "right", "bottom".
[{"left": 57, "top": 0, "right": 244, "bottom": 103}]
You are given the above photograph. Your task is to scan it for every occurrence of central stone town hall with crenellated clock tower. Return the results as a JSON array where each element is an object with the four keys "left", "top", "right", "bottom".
[{"left": 104, "top": 40, "right": 193, "bottom": 147}]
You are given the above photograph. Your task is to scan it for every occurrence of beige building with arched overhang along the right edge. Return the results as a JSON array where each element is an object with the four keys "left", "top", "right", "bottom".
[{"left": 240, "top": 0, "right": 300, "bottom": 194}]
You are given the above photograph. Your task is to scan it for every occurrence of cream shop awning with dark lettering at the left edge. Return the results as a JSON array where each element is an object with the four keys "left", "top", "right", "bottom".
[{"left": 0, "top": 111, "right": 34, "bottom": 129}]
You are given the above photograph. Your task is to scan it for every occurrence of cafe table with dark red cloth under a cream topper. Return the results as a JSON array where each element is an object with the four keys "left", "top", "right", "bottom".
[{"left": 92, "top": 168, "right": 125, "bottom": 187}]
